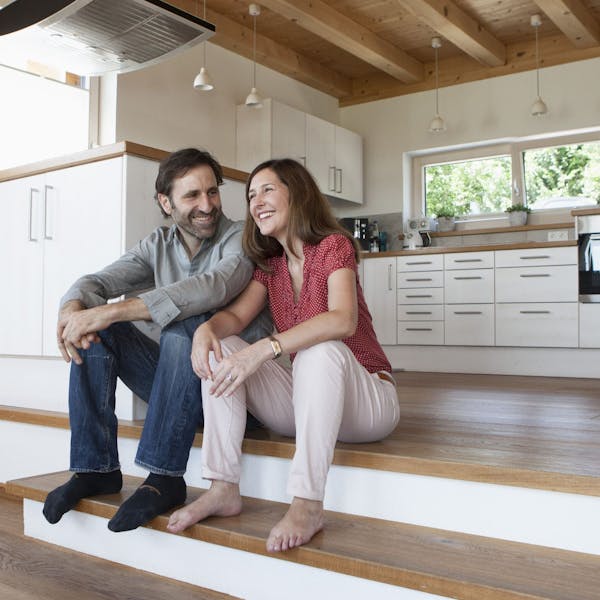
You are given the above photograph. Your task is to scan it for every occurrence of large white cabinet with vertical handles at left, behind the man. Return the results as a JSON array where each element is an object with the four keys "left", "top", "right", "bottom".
[{"left": 0, "top": 155, "right": 163, "bottom": 356}]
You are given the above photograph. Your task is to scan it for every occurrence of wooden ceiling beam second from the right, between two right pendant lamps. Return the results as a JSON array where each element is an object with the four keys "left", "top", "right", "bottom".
[{"left": 398, "top": 0, "right": 506, "bottom": 67}]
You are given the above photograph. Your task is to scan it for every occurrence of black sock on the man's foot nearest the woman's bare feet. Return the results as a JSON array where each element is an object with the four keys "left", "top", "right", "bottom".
[{"left": 108, "top": 473, "right": 187, "bottom": 531}]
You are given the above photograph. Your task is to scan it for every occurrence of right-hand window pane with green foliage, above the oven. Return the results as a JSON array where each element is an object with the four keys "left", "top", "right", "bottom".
[{"left": 523, "top": 142, "right": 600, "bottom": 210}]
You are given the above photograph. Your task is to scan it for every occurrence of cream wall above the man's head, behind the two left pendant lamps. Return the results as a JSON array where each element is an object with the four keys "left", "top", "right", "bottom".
[{"left": 111, "top": 44, "right": 339, "bottom": 167}]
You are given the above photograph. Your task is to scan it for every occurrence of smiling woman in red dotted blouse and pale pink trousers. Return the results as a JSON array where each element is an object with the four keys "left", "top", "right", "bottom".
[{"left": 168, "top": 159, "right": 400, "bottom": 551}]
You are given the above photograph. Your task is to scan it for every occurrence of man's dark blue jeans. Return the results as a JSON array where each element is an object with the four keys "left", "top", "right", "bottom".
[{"left": 69, "top": 314, "right": 210, "bottom": 476}]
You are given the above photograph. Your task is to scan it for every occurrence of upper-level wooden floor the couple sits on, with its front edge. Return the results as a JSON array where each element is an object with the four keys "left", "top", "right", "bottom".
[{"left": 0, "top": 372, "right": 600, "bottom": 496}]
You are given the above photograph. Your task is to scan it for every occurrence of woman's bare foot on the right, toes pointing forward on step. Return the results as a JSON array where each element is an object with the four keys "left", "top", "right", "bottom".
[{"left": 267, "top": 498, "right": 323, "bottom": 552}]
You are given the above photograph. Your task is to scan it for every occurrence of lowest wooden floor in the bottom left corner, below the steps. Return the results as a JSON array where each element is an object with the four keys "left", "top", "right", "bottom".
[{"left": 0, "top": 492, "right": 237, "bottom": 600}]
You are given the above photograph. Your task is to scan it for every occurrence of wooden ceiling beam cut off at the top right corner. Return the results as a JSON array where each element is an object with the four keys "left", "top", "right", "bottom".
[{"left": 534, "top": 0, "right": 600, "bottom": 48}]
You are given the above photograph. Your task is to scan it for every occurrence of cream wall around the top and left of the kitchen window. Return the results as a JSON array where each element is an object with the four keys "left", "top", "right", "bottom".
[{"left": 338, "top": 58, "right": 600, "bottom": 216}]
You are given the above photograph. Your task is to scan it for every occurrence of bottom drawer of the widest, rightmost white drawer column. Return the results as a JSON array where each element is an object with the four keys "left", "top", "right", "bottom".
[{"left": 496, "top": 302, "right": 579, "bottom": 348}]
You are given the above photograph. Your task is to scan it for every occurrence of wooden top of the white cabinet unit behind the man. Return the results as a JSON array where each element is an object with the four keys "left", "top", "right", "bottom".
[{"left": 0, "top": 141, "right": 248, "bottom": 183}]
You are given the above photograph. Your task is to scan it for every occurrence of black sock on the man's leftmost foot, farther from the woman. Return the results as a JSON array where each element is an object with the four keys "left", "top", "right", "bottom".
[{"left": 42, "top": 470, "right": 123, "bottom": 524}]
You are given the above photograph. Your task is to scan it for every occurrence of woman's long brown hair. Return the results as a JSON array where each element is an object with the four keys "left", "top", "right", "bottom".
[{"left": 242, "top": 158, "right": 360, "bottom": 272}]
